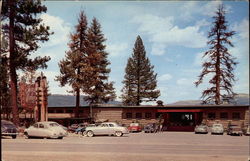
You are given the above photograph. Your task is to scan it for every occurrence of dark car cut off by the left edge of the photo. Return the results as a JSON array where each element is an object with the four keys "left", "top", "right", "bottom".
[{"left": 1, "top": 120, "right": 18, "bottom": 139}]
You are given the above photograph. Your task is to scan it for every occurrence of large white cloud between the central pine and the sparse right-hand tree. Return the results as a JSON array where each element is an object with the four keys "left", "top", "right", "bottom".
[{"left": 132, "top": 14, "right": 207, "bottom": 55}]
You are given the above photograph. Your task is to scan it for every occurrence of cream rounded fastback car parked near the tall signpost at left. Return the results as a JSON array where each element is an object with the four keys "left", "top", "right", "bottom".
[{"left": 24, "top": 121, "right": 68, "bottom": 139}]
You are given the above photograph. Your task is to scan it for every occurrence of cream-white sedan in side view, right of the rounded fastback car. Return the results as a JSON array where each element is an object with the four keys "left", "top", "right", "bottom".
[{"left": 85, "top": 122, "right": 129, "bottom": 137}]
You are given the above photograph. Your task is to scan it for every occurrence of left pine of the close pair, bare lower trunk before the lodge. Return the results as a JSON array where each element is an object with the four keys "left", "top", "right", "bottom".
[{"left": 56, "top": 11, "right": 87, "bottom": 117}]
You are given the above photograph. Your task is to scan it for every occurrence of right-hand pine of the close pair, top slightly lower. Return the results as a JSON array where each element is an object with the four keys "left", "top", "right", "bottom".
[{"left": 82, "top": 18, "right": 116, "bottom": 105}]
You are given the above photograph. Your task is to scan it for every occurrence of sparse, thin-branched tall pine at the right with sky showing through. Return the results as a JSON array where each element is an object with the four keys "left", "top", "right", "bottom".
[{"left": 195, "top": 5, "right": 237, "bottom": 105}]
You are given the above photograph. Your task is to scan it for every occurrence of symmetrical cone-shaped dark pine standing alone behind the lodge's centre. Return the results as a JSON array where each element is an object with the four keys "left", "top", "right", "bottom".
[{"left": 121, "top": 36, "right": 160, "bottom": 105}]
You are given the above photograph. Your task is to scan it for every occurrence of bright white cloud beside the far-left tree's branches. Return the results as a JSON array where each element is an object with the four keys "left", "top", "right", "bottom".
[{"left": 40, "top": 13, "right": 71, "bottom": 46}]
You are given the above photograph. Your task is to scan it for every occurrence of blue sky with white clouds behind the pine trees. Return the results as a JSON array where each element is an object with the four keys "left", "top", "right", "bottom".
[{"left": 33, "top": 1, "right": 249, "bottom": 104}]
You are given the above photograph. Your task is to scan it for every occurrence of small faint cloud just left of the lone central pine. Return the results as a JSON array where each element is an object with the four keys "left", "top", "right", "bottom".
[{"left": 106, "top": 43, "right": 128, "bottom": 57}]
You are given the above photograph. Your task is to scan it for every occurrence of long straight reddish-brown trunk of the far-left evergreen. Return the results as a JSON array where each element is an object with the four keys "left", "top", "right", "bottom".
[{"left": 9, "top": 0, "right": 19, "bottom": 125}]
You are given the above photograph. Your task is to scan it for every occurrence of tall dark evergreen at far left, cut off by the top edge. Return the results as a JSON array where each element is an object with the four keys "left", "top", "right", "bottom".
[{"left": 1, "top": 0, "right": 51, "bottom": 124}]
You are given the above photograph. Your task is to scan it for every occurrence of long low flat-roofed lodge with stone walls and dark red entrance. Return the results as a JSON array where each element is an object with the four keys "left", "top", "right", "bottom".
[{"left": 48, "top": 104, "right": 250, "bottom": 131}]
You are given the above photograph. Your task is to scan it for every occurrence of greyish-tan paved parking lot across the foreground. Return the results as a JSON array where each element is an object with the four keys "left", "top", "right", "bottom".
[{"left": 2, "top": 132, "right": 249, "bottom": 161}]
